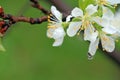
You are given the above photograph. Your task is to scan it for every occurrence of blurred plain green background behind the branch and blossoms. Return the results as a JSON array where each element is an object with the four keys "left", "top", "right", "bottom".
[{"left": 0, "top": 0, "right": 120, "bottom": 80}]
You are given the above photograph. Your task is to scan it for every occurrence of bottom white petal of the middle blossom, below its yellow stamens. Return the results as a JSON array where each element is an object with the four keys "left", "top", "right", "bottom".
[{"left": 84, "top": 26, "right": 98, "bottom": 42}]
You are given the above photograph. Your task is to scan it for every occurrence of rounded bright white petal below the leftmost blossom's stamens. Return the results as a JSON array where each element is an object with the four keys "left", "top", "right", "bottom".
[{"left": 53, "top": 27, "right": 65, "bottom": 39}]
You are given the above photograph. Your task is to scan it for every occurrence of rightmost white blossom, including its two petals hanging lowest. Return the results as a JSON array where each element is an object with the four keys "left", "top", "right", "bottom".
[{"left": 88, "top": 7, "right": 120, "bottom": 57}]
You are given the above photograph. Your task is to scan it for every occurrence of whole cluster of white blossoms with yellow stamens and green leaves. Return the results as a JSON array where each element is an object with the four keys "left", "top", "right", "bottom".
[{"left": 47, "top": 0, "right": 120, "bottom": 58}]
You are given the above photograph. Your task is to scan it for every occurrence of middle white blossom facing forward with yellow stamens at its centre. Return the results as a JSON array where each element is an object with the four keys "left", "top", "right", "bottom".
[{"left": 67, "top": 4, "right": 97, "bottom": 40}]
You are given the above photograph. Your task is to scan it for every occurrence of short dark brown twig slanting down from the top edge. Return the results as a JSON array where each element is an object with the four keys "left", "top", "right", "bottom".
[{"left": 30, "top": 0, "right": 50, "bottom": 15}]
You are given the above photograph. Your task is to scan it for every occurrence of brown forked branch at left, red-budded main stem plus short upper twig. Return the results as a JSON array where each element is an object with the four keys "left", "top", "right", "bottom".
[{"left": 0, "top": 0, "right": 50, "bottom": 36}]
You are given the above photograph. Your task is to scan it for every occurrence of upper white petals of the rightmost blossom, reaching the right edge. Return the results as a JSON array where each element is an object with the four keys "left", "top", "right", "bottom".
[{"left": 94, "top": 7, "right": 120, "bottom": 34}]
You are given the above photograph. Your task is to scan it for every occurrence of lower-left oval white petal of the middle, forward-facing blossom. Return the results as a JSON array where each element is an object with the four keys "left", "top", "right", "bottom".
[{"left": 67, "top": 22, "right": 82, "bottom": 37}]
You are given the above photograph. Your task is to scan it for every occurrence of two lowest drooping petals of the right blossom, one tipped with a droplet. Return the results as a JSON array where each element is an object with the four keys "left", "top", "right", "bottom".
[{"left": 88, "top": 32, "right": 115, "bottom": 58}]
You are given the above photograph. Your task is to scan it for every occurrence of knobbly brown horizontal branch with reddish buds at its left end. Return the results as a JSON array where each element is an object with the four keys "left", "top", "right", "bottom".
[{"left": 0, "top": 7, "right": 48, "bottom": 36}]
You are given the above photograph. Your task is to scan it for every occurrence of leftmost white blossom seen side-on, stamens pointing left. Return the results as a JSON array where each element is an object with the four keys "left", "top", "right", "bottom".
[{"left": 47, "top": 6, "right": 65, "bottom": 46}]
